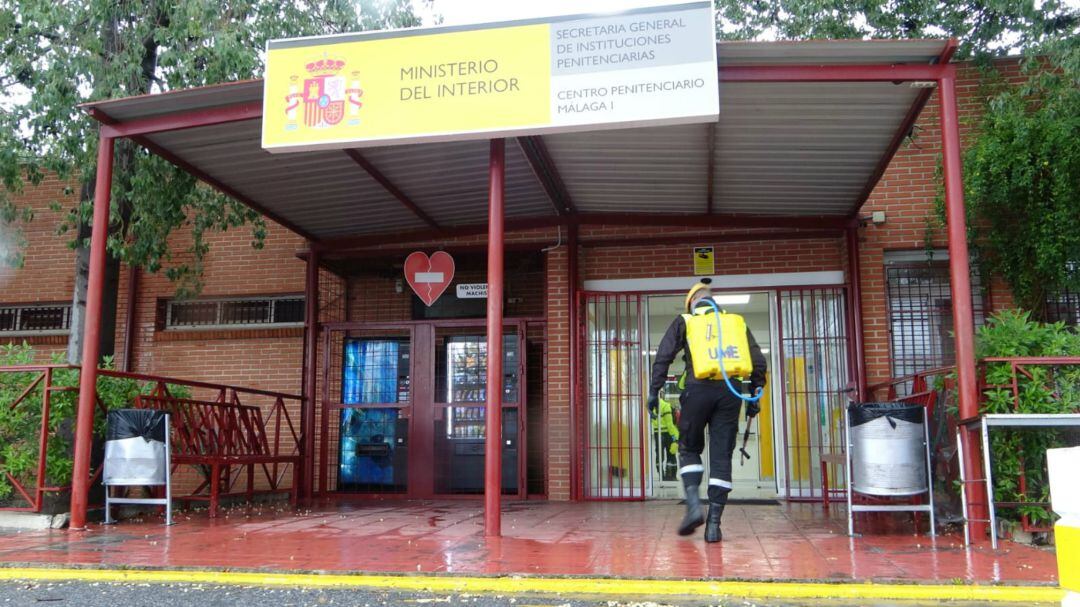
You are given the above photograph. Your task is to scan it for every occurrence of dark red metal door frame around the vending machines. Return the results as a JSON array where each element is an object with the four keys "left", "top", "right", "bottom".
[{"left": 316, "top": 316, "right": 545, "bottom": 500}]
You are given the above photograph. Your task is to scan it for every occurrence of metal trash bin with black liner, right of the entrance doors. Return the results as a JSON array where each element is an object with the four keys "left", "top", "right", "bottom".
[{"left": 843, "top": 403, "right": 936, "bottom": 536}]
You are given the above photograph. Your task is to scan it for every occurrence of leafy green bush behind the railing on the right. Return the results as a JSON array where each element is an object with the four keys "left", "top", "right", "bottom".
[{"left": 976, "top": 310, "right": 1080, "bottom": 524}]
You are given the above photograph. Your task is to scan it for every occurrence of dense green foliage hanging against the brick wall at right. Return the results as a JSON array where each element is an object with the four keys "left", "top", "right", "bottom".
[{"left": 964, "top": 53, "right": 1080, "bottom": 316}]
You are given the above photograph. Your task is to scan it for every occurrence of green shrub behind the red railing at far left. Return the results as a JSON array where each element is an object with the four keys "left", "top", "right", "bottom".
[{"left": 0, "top": 342, "right": 147, "bottom": 505}]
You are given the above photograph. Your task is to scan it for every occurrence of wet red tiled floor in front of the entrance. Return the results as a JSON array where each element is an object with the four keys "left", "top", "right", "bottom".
[{"left": 0, "top": 500, "right": 1057, "bottom": 584}]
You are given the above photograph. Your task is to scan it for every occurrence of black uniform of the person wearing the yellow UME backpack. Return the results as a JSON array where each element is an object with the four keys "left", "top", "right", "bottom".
[{"left": 649, "top": 304, "right": 767, "bottom": 504}]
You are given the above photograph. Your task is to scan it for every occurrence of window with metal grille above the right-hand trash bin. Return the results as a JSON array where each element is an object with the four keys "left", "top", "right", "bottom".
[{"left": 886, "top": 261, "right": 985, "bottom": 392}]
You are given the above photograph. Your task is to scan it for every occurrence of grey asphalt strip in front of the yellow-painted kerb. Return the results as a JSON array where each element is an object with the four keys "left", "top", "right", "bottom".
[{"left": 0, "top": 581, "right": 1032, "bottom": 607}]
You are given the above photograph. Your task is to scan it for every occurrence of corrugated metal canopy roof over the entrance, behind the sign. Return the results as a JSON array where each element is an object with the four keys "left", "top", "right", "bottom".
[{"left": 90, "top": 40, "right": 947, "bottom": 241}]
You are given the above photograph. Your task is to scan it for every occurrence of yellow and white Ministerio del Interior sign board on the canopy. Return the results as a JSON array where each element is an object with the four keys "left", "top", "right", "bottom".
[{"left": 262, "top": 1, "right": 719, "bottom": 151}]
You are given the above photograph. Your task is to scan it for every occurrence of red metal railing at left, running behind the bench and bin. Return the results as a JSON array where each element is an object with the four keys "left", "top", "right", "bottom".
[{"left": 0, "top": 365, "right": 302, "bottom": 512}]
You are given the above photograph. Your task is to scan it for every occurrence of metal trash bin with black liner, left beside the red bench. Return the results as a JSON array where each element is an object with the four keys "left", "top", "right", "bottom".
[{"left": 102, "top": 409, "right": 173, "bottom": 525}]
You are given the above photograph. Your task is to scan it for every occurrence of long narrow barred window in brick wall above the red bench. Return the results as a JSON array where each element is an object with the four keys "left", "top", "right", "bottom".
[{"left": 165, "top": 295, "right": 303, "bottom": 328}]
